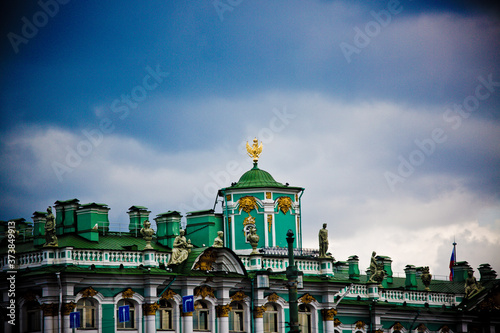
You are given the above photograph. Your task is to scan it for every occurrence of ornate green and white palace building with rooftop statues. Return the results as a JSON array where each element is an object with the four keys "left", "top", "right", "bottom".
[{"left": 0, "top": 152, "right": 500, "bottom": 333}]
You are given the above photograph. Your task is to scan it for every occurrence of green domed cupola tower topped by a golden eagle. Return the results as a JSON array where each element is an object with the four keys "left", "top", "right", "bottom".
[{"left": 219, "top": 139, "right": 304, "bottom": 254}]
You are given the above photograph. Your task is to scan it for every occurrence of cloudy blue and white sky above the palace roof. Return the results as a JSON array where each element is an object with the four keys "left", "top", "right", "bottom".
[{"left": 0, "top": 0, "right": 500, "bottom": 277}]
